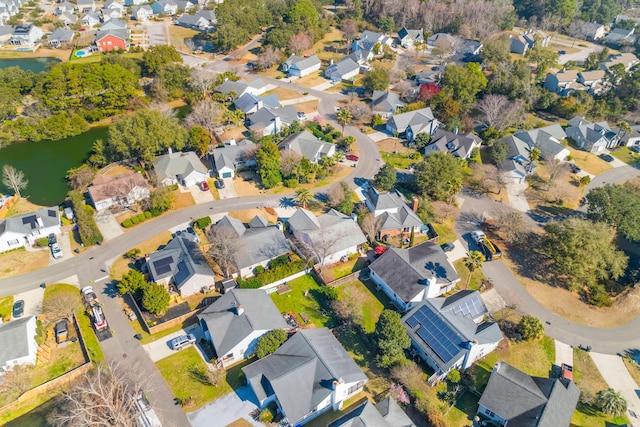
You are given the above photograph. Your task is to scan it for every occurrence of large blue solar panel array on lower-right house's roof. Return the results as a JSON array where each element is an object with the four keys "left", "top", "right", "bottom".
[{"left": 407, "top": 305, "right": 464, "bottom": 363}]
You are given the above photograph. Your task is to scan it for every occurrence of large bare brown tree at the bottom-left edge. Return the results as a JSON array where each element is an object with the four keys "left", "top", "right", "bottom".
[{"left": 49, "top": 363, "right": 144, "bottom": 427}]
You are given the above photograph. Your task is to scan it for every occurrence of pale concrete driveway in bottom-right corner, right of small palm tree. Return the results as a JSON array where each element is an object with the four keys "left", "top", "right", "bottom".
[{"left": 589, "top": 352, "right": 640, "bottom": 427}]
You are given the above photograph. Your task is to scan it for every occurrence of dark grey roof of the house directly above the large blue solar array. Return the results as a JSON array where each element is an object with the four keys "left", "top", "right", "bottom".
[{"left": 369, "top": 242, "right": 460, "bottom": 302}]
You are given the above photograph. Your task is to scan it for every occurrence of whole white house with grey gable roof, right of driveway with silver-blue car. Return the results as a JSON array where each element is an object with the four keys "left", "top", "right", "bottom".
[{"left": 198, "top": 289, "right": 289, "bottom": 368}]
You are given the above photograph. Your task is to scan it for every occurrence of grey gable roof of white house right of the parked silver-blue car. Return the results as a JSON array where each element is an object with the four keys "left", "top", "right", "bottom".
[{"left": 198, "top": 288, "right": 288, "bottom": 357}]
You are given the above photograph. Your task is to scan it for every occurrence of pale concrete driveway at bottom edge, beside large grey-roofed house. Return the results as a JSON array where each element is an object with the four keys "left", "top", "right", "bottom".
[{"left": 187, "top": 386, "right": 263, "bottom": 427}]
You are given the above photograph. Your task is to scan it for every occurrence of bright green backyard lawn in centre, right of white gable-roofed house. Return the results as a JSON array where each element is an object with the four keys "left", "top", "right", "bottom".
[{"left": 271, "top": 275, "right": 337, "bottom": 328}]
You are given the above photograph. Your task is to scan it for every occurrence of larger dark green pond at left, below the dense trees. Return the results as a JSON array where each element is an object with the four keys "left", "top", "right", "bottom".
[{"left": 0, "top": 127, "right": 107, "bottom": 206}]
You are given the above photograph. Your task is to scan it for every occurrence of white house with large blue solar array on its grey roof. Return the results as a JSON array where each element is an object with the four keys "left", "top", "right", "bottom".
[{"left": 402, "top": 291, "right": 502, "bottom": 378}]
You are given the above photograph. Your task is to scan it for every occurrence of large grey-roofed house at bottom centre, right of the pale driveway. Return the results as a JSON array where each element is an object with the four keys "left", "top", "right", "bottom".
[{"left": 242, "top": 328, "right": 368, "bottom": 426}]
